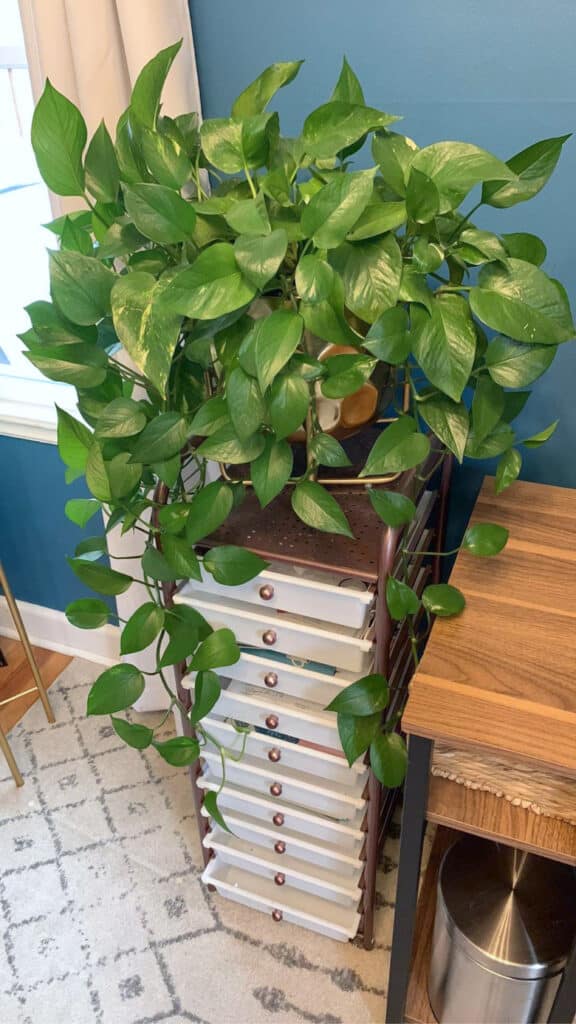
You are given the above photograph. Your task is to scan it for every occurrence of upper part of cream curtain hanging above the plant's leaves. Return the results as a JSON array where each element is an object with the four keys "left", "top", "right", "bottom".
[{"left": 19, "top": 0, "right": 200, "bottom": 213}]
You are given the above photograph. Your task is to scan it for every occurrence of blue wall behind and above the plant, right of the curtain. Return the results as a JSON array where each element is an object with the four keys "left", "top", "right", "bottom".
[{"left": 191, "top": 0, "right": 576, "bottom": 544}]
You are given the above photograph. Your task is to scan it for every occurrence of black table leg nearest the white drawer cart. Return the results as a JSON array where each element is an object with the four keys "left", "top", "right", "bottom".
[{"left": 386, "top": 736, "right": 433, "bottom": 1024}]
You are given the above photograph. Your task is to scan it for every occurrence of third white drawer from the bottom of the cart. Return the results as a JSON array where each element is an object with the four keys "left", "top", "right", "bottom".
[{"left": 202, "top": 798, "right": 364, "bottom": 884}]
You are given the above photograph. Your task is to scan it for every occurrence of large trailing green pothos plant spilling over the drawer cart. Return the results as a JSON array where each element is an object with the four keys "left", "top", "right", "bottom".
[{"left": 28, "top": 44, "right": 575, "bottom": 802}]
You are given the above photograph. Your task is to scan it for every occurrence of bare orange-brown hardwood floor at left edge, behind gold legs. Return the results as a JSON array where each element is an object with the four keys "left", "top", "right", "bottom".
[{"left": 0, "top": 637, "right": 72, "bottom": 734}]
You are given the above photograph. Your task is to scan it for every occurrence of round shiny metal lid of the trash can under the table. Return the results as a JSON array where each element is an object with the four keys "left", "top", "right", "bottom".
[{"left": 438, "top": 836, "right": 576, "bottom": 979}]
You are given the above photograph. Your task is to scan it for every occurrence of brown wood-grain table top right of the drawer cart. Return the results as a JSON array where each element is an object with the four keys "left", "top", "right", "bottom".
[{"left": 403, "top": 477, "right": 576, "bottom": 774}]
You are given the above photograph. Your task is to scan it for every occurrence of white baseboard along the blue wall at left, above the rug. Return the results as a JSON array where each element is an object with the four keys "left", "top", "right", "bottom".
[{"left": 0, "top": 597, "right": 120, "bottom": 665}]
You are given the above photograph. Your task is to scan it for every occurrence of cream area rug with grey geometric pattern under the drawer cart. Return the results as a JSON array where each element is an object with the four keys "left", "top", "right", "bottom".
[{"left": 0, "top": 660, "right": 398, "bottom": 1024}]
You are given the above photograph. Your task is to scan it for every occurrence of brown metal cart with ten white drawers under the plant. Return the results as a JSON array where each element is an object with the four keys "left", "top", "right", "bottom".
[{"left": 168, "top": 447, "right": 451, "bottom": 948}]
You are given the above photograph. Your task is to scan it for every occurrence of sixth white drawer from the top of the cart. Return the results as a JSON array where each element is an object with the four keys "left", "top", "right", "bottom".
[{"left": 202, "top": 748, "right": 365, "bottom": 821}]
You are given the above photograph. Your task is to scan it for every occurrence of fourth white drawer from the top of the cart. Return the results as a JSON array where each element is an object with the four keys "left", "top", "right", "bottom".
[{"left": 201, "top": 679, "right": 342, "bottom": 752}]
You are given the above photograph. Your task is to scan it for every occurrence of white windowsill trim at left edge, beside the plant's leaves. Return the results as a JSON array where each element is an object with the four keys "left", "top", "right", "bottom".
[{"left": 0, "top": 367, "right": 78, "bottom": 444}]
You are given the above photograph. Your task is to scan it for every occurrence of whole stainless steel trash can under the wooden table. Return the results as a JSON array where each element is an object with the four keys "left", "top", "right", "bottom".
[{"left": 428, "top": 836, "right": 576, "bottom": 1024}]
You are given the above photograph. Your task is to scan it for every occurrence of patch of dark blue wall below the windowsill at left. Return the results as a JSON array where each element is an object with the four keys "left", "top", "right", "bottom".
[{"left": 0, "top": 437, "right": 108, "bottom": 609}]
